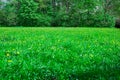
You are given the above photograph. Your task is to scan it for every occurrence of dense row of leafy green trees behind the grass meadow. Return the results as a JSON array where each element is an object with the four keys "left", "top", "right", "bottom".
[{"left": 0, "top": 0, "right": 120, "bottom": 27}]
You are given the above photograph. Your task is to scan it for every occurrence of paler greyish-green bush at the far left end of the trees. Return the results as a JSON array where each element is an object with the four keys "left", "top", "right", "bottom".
[{"left": 0, "top": 2, "right": 17, "bottom": 26}]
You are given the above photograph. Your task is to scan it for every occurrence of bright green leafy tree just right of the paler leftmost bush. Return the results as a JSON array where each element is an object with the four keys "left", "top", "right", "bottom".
[{"left": 18, "top": 0, "right": 38, "bottom": 26}]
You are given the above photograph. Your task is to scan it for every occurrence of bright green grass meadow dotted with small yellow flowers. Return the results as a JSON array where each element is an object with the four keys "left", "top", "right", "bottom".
[{"left": 0, "top": 28, "right": 120, "bottom": 80}]
